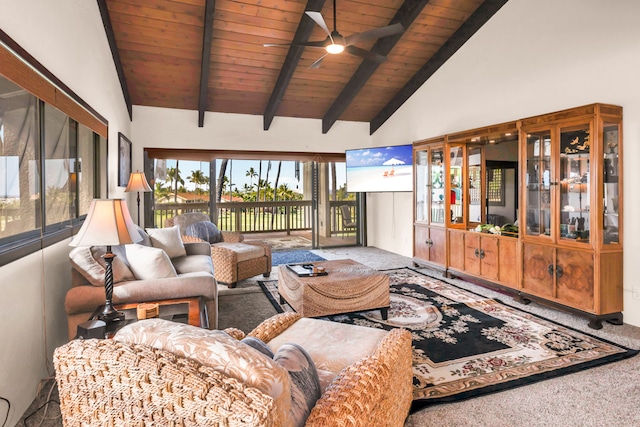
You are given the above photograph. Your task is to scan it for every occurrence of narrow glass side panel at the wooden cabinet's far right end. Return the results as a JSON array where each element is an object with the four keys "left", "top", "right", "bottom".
[{"left": 602, "top": 123, "right": 620, "bottom": 244}]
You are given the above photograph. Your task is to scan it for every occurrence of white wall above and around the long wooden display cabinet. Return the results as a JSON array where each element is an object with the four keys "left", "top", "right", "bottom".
[{"left": 368, "top": 0, "right": 640, "bottom": 326}]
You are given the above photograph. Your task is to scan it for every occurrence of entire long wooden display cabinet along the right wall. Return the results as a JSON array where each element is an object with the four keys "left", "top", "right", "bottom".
[{"left": 414, "top": 104, "right": 623, "bottom": 329}]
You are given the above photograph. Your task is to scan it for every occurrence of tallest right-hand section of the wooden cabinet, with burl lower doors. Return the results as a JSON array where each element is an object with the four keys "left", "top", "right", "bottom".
[{"left": 520, "top": 104, "right": 622, "bottom": 329}]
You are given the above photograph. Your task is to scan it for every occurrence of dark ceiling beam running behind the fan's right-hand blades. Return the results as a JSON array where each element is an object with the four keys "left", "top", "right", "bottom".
[{"left": 322, "top": 0, "right": 429, "bottom": 133}]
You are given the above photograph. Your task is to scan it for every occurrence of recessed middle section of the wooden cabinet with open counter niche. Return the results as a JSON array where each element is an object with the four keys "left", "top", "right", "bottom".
[{"left": 447, "top": 122, "right": 519, "bottom": 289}]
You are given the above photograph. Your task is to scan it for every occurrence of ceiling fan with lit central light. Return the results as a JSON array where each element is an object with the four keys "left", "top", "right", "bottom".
[{"left": 264, "top": 0, "right": 404, "bottom": 68}]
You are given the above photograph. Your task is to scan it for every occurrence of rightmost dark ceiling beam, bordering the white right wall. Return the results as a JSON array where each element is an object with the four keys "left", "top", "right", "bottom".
[{"left": 369, "top": 0, "right": 508, "bottom": 135}]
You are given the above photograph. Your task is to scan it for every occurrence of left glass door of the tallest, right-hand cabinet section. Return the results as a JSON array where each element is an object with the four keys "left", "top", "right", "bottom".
[{"left": 525, "top": 130, "right": 551, "bottom": 236}]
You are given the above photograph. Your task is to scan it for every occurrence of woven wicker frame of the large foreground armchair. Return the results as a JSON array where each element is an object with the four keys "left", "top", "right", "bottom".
[{"left": 54, "top": 313, "right": 412, "bottom": 427}]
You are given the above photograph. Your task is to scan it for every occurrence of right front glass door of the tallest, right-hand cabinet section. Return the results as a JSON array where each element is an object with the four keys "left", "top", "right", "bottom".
[{"left": 558, "top": 124, "right": 591, "bottom": 243}]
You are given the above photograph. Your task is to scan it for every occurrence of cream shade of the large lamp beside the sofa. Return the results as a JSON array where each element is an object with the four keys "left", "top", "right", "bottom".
[{"left": 69, "top": 199, "right": 142, "bottom": 246}]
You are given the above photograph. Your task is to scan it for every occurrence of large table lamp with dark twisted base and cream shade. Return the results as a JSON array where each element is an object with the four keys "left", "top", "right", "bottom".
[{"left": 69, "top": 199, "right": 142, "bottom": 323}]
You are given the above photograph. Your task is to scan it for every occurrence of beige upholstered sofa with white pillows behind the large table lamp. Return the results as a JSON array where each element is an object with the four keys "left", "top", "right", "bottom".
[{"left": 65, "top": 227, "right": 218, "bottom": 339}]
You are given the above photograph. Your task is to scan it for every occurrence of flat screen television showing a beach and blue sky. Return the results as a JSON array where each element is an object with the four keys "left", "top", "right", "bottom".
[{"left": 345, "top": 144, "right": 413, "bottom": 193}]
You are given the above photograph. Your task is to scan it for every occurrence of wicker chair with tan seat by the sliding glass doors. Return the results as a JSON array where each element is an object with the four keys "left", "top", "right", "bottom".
[{"left": 164, "top": 212, "right": 271, "bottom": 288}]
